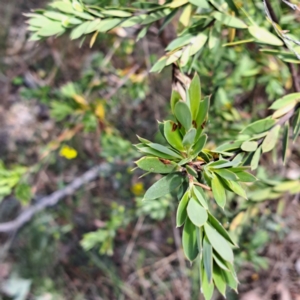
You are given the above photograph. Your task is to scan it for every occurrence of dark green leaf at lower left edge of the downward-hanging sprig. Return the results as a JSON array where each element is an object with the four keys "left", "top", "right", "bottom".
[{"left": 182, "top": 218, "right": 199, "bottom": 262}]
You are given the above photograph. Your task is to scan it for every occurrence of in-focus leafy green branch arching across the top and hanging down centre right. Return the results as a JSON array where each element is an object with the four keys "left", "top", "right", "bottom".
[{"left": 19, "top": 0, "right": 300, "bottom": 299}]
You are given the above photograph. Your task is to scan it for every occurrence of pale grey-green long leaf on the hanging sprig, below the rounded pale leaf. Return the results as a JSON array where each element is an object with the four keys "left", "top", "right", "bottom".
[{"left": 204, "top": 223, "right": 233, "bottom": 262}]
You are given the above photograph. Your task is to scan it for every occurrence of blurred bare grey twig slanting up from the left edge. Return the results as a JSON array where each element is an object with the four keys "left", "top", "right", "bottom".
[{"left": 0, "top": 163, "right": 110, "bottom": 232}]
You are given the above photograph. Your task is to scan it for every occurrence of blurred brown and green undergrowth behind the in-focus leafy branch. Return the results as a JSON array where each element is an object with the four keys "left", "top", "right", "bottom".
[{"left": 0, "top": 0, "right": 300, "bottom": 300}]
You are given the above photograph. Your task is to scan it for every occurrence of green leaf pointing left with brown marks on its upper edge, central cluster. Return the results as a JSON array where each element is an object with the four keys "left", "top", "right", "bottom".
[{"left": 135, "top": 157, "right": 177, "bottom": 174}]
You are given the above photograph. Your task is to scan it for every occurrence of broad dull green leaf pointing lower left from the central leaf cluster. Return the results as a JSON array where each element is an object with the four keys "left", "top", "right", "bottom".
[{"left": 144, "top": 173, "right": 183, "bottom": 200}]
